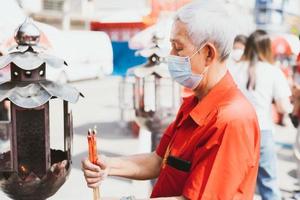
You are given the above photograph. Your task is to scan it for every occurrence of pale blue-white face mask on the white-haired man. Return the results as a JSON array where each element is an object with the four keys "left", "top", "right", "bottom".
[{"left": 168, "top": 44, "right": 207, "bottom": 90}]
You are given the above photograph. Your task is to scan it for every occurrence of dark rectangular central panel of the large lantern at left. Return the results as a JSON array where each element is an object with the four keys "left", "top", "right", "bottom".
[{"left": 16, "top": 108, "right": 50, "bottom": 177}]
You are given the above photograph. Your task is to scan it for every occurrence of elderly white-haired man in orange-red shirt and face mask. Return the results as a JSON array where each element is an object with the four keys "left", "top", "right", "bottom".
[{"left": 82, "top": 0, "right": 260, "bottom": 200}]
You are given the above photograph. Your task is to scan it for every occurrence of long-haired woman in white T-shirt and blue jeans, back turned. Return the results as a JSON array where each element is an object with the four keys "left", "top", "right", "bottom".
[{"left": 233, "top": 30, "right": 292, "bottom": 200}]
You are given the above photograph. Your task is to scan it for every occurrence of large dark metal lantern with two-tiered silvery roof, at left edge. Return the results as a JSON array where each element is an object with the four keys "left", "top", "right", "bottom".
[{"left": 0, "top": 20, "right": 81, "bottom": 200}]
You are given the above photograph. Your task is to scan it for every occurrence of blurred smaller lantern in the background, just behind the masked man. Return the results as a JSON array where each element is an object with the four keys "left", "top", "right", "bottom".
[{"left": 120, "top": 36, "right": 180, "bottom": 150}]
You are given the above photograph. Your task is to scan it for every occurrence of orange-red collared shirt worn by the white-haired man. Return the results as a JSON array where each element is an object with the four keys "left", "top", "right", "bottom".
[{"left": 151, "top": 73, "right": 260, "bottom": 200}]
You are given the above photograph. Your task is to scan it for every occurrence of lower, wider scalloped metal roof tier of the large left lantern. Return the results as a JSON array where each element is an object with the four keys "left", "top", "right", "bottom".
[{"left": 0, "top": 80, "right": 83, "bottom": 109}]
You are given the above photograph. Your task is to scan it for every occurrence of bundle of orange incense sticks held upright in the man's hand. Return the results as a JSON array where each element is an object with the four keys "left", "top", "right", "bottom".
[{"left": 87, "top": 128, "right": 100, "bottom": 200}]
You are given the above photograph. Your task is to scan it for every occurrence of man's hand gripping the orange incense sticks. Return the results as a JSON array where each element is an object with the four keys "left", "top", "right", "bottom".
[{"left": 81, "top": 156, "right": 110, "bottom": 188}]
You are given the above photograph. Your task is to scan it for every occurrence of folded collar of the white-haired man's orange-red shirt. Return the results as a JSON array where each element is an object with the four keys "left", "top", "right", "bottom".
[{"left": 190, "top": 71, "right": 237, "bottom": 126}]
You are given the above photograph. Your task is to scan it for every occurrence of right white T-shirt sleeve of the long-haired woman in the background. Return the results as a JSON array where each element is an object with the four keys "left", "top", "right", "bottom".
[{"left": 273, "top": 68, "right": 292, "bottom": 100}]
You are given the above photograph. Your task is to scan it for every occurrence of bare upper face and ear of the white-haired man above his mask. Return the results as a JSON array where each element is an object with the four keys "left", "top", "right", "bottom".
[{"left": 170, "top": 21, "right": 205, "bottom": 74}]
